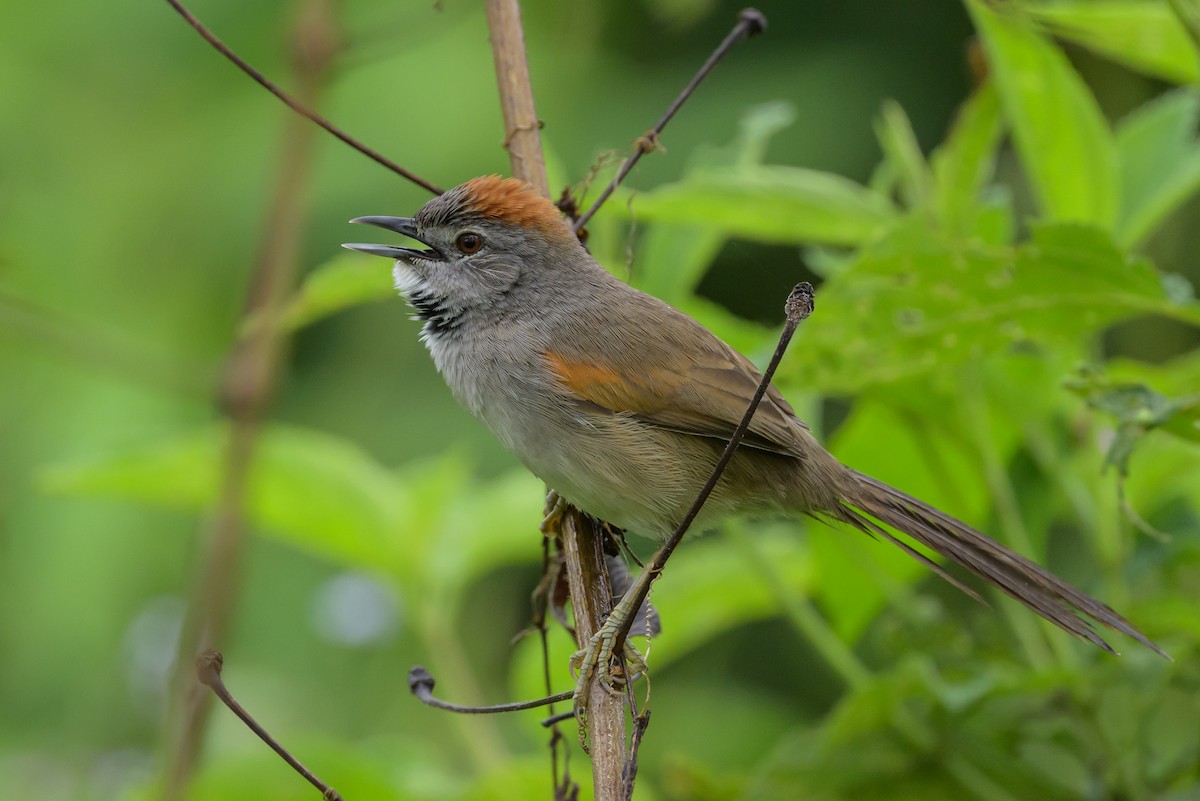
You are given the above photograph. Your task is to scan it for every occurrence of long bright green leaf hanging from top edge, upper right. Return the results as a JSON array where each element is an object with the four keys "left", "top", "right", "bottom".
[{"left": 967, "top": 0, "right": 1120, "bottom": 228}]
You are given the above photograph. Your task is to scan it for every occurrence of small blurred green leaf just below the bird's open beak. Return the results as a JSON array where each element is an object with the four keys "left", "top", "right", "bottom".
[{"left": 283, "top": 253, "right": 396, "bottom": 330}]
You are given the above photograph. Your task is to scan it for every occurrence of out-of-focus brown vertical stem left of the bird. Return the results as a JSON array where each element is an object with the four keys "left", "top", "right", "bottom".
[{"left": 162, "top": 0, "right": 336, "bottom": 800}]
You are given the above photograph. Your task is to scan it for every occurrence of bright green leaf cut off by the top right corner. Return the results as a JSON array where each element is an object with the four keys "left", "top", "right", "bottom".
[{"left": 1025, "top": 0, "right": 1200, "bottom": 84}]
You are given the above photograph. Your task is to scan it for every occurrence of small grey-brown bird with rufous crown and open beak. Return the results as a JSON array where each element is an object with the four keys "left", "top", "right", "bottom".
[{"left": 344, "top": 175, "right": 1166, "bottom": 656}]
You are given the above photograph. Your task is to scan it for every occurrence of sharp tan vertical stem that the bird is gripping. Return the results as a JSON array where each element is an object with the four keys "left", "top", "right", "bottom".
[{"left": 487, "top": 0, "right": 626, "bottom": 801}]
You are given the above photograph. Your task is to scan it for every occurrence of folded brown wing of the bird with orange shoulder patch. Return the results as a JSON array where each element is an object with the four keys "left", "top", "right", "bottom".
[{"left": 542, "top": 295, "right": 806, "bottom": 457}]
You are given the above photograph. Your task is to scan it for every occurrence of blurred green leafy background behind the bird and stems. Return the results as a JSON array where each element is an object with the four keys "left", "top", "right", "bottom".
[{"left": 0, "top": 0, "right": 1200, "bottom": 801}]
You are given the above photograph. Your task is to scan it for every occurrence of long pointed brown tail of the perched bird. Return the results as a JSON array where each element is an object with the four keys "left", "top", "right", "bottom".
[{"left": 829, "top": 469, "right": 1170, "bottom": 658}]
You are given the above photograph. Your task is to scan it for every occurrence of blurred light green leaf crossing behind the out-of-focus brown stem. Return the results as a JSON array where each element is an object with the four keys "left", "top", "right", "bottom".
[{"left": 44, "top": 426, "right": 408, "bottom": 568}]
